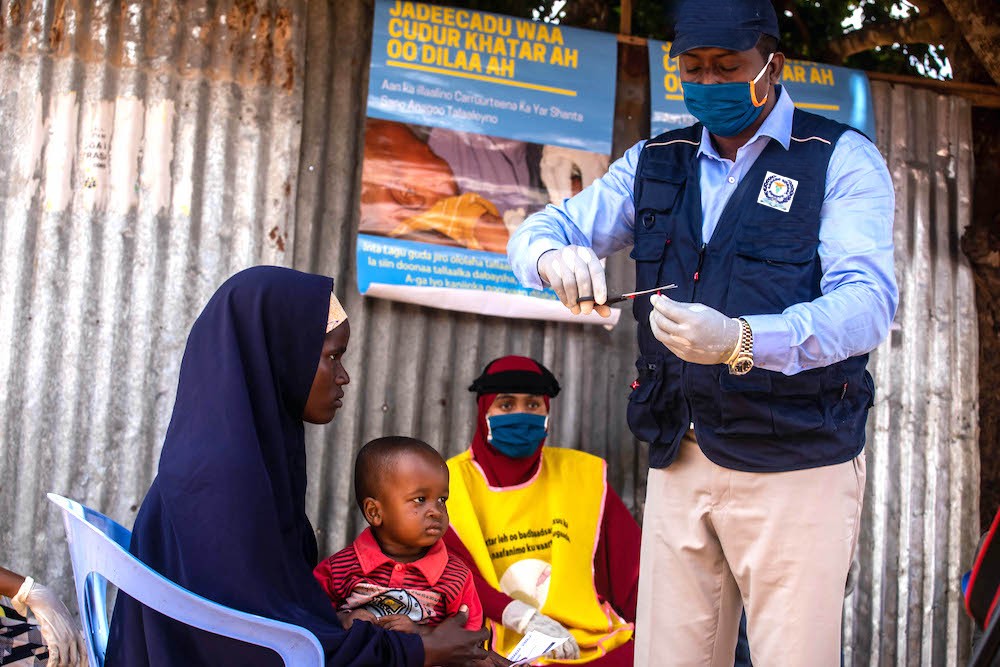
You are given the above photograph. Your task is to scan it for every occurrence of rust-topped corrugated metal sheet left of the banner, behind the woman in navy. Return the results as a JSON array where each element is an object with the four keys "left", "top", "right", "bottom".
[{"left": 0, "top": 0, "right": 305, "bottom": 592}]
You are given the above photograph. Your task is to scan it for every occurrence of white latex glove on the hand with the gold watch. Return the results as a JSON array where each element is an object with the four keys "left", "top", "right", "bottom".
[{"left": 649, "top": 294, "right": 740, "bottom": 364}]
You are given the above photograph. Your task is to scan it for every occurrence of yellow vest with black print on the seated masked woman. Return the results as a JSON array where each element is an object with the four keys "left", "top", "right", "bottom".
[{"left": 448, "top": 447, "right": 632, "bottom": 665}]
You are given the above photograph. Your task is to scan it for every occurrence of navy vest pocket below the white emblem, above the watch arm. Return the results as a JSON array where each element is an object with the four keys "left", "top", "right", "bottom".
[{"left": 727, "top": 235, "right": 820, "bottom": 315}]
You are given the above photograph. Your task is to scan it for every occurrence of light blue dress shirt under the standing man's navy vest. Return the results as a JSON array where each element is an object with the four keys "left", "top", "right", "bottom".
[{"left": 507, "top": 87, "right": 899, "bottom": 375}]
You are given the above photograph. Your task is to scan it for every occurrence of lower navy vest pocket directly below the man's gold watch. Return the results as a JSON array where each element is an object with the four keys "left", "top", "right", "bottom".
[{"left": 718, "top": 370, "right": 826, "bottom": 437}]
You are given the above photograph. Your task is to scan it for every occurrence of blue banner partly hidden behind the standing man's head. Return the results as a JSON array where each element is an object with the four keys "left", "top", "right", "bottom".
[{"left": 648, "top": 39, "right": 875, "bottom": 139}]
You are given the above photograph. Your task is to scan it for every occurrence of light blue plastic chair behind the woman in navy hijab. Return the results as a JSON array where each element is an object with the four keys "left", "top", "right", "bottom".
[{"left": 48, "top": 493, "right": 324, "bottom": 667}]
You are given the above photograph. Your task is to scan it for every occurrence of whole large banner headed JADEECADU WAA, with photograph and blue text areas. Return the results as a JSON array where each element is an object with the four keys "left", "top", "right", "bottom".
[{"left": 357, "top": 0, "right": 617, "bottom": 324}]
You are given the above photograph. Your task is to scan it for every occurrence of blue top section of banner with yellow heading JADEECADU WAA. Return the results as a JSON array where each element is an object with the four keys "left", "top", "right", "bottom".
[{"left": 368, "top": 0, "right": 618, "bottom": 154}]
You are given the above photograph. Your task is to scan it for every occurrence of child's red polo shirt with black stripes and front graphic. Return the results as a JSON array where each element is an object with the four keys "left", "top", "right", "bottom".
[{"left": 313, "top": 528, "right": 483, "bottom": 630}]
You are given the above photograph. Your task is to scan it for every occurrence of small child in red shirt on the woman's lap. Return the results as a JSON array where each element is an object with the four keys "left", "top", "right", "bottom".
[{"left": 313, "top": 436, "right": 483, "bottom": 634}]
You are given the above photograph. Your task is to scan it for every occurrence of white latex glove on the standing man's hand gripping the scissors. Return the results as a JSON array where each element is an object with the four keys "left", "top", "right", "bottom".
[{"left": 538, "top": 245, "right": 611, "bottom": 317}]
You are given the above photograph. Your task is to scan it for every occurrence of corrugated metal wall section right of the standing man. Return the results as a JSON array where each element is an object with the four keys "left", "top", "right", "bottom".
[{"left": 845, "top": 82, "right": 979, "bottom": 665}]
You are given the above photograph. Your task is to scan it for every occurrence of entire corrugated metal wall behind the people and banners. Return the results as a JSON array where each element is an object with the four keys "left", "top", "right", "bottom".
[{"left": 0, "top": 0, "right": 978, "bottom": 665}]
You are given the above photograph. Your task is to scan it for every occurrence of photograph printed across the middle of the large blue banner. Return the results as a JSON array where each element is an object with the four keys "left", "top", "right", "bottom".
[{"left": 359, "top": 118, "right": 608, "bottom": 253}]
